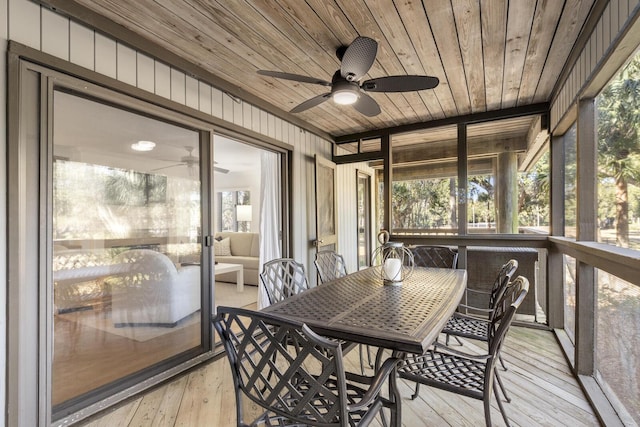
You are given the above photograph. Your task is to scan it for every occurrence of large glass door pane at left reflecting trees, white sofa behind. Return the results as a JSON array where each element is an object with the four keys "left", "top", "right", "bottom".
[{"left": 50, "top": 90, "right": 210, "bottom": 415}]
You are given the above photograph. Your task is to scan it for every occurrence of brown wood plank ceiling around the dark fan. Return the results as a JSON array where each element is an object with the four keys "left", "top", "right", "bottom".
[{"left": 53, "top": 0, "right": 596, "bottom": 137}]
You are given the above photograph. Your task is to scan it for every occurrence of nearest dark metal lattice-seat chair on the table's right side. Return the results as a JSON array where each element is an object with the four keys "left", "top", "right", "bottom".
[{"left": 398, "top": 276, "right": 529, "bottom": 427}]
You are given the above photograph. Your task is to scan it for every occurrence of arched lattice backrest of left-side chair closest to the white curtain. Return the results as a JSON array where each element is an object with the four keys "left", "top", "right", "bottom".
[{"left": 260, "top": 258, "right": 309, "bottom": 304}]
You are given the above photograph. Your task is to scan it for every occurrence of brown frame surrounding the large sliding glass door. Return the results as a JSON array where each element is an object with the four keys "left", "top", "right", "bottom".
[{"left": 5, "top": 42, "right": 292, "bottom": 426}]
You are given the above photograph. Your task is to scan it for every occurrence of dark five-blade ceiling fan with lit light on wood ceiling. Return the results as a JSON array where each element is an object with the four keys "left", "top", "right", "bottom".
[{"left": 258, "top": 37, "right": 440, "bottom": 117}]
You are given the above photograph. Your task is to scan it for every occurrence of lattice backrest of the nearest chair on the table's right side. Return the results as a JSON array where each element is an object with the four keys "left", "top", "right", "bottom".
[{"left": 488, "top": 276, "right": 529, "bottom": 359}]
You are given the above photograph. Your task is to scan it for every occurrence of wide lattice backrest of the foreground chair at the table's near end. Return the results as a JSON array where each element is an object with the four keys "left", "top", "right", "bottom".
[{"left": 213, "top": 307, "right": 349, "bottom": 427}]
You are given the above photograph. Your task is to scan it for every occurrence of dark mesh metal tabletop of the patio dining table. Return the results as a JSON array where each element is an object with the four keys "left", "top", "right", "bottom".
[{"left": 264, "top": 267, "right": 467, "bottom": 353}]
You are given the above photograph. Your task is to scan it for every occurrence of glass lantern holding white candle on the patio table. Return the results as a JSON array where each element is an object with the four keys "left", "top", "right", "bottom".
[{"left": 371, "top": 230, "right": 413, "bottom": 286}]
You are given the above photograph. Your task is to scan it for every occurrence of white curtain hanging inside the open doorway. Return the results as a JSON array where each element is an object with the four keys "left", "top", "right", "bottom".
[{"left": 258, "top": 151, "right": 282, "bottom": 309}]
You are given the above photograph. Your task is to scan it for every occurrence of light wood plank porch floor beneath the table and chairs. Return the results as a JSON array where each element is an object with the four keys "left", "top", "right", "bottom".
[{"left": 82, "top": 327, "right": 600, "bottom": 427}]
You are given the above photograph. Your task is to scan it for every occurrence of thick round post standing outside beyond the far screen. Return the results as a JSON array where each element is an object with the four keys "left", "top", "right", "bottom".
[{"left": 496, "top": 151, "right": 518, "bottom": 234}]
